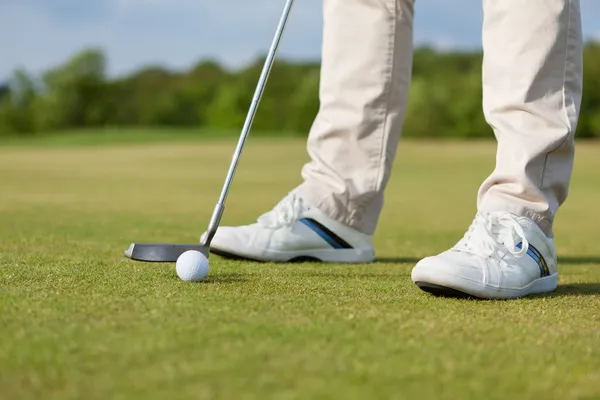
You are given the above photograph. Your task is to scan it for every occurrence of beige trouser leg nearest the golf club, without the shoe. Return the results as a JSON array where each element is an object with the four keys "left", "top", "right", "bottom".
[{"left": 294, "top": 0, "right": 413, "bottom": 235}]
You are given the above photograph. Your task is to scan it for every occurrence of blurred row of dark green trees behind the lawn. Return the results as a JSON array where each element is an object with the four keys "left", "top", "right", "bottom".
[{"left": 0, "top": 43, "right": 600, "bottom": 138}]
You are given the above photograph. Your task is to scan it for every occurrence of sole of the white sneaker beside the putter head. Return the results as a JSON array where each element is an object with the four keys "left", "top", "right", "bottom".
[{"left": 210, "top": 247, "right": 375, "bottom": 264}]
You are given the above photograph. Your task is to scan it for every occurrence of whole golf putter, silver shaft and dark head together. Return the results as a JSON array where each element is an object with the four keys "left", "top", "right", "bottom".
[{"left": 125, "top": 0, "right": 294, "bottom": 262}]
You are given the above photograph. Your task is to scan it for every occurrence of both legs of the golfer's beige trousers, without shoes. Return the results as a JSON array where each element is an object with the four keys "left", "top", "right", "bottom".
[{"left": 294, "top": 0, "right": 583, "bottom": 236}]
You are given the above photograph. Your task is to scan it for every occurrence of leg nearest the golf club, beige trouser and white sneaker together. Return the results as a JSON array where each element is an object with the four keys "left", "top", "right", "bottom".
[{"left": 204, "top": 0, "right": 413, "bottom": 262}]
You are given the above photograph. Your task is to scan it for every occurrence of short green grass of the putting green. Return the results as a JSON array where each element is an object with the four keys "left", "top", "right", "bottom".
[{"left": 0, "top": 132, "right": 600, "bottom": 399}]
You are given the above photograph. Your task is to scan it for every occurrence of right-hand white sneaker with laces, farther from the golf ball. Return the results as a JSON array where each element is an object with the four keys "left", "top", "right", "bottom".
[{"left": 412, "top": 212, "right": 558, "bottom": 299}]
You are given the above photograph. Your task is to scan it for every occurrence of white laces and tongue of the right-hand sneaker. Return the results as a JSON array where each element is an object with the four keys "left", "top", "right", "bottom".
[{"left": 457, "top": 213, "right": 529, "bottom": 258}]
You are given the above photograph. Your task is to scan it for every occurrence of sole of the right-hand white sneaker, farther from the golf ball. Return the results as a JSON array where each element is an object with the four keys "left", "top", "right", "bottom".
[{"left": 412, "top": 268, "right": 558, "bottom": 300}]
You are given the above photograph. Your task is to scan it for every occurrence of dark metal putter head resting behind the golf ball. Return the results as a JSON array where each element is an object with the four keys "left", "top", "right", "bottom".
[{"left": 125, "top": 243, "right": 210, "bottom": 263}]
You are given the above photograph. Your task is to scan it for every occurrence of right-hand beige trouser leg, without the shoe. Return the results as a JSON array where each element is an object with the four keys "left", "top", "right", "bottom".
[{"left": 478, "top": 0, "right": 583, "bottom": 236}]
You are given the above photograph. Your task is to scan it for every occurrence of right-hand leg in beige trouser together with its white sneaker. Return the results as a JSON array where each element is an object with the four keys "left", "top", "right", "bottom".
[{"left": 412, "top": 0, "right": 583, "bottom": 298}]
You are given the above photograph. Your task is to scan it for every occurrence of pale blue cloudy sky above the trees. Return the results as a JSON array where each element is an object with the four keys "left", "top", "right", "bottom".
[{"left": 0, "top": 0, "right": 600, "bottom": 79}]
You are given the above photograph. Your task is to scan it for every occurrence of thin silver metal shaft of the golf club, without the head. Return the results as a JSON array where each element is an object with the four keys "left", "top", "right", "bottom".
[{"left": 203, "top": 0, "right": 294, "bottom": 246}]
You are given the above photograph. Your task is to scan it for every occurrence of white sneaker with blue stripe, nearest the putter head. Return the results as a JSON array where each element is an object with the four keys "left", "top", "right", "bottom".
[{"left": 201, "top": 194, "right": 375, "bottom": 263}]
